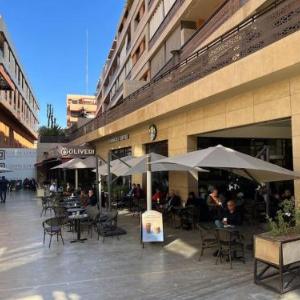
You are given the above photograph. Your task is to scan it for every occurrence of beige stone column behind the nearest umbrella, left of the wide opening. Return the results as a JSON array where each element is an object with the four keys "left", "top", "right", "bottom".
[{"left": 168, "top": 135, "right": 198, "bottom": 201}]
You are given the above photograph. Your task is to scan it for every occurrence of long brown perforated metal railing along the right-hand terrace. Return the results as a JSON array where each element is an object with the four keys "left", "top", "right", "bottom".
[{"left": 70, "top": 0, "right": 300, "bottom": 140}]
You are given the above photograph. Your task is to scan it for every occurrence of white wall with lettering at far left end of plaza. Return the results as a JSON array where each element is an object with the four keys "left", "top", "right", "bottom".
[{"left": 0, "top": 148, "right": 37, "bottom": 180}]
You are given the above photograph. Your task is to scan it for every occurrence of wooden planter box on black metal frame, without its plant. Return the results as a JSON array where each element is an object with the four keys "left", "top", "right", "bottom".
[{"left": 254, "top": 233, "right": 300, "bottom": 294}]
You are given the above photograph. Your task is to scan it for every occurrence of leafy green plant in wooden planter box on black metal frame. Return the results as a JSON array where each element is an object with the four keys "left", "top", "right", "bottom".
[{"left": 254, "top": 200, "right": 300, "bottom": 293}]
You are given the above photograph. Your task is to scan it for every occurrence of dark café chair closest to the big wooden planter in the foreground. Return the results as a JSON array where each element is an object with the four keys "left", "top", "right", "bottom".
[{"left": 216, "top": 228, "right": 246, "bottom": 269}]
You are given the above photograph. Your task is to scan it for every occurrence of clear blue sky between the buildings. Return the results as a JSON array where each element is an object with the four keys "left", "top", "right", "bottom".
[{"left": 0, "top": 0, "right": 126, "bottom": 126}]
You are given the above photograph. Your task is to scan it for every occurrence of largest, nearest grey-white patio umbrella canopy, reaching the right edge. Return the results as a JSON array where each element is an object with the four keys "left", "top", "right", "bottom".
[{"left": 152, "top": 145, "right": 300, "bottom": 183}]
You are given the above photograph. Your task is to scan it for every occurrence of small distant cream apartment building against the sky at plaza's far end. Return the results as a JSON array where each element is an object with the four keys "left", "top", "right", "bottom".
[{"left": 67, "top": 94, "right": 97, "bottom": 128}]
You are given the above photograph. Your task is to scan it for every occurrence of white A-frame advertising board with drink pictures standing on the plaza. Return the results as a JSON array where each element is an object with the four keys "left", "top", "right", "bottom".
[{"left": 141, "top": 210, "right": 164, "bottom": 243}]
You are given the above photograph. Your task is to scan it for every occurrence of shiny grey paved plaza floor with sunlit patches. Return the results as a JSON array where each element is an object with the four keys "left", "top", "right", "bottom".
[{"left": 0, "top": 192, "right": 300, "bottom": 300}]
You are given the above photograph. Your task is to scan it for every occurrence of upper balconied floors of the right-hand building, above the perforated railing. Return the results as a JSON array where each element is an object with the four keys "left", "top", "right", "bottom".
[{"left": 97, "top": 0, "right": 230, "bottom": 114}]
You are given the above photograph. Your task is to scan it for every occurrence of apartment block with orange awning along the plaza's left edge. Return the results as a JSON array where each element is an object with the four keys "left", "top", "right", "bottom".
[{"left": 0, "top": 16, "right": 39, "bottom": 148}]
